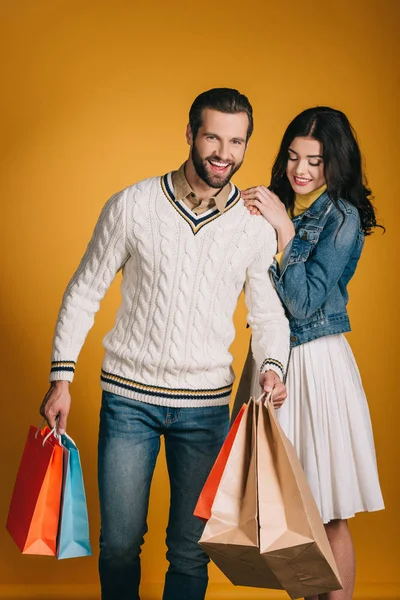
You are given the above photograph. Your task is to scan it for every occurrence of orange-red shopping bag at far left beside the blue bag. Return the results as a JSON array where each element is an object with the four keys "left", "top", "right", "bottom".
[{"left": 6, "top": 426, "right": 62, "bottom": 556}]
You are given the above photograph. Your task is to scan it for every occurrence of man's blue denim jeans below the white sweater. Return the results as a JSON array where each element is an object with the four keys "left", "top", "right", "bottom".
[{"left": 99, "top": 392, "right": 229, "bottom": 600}]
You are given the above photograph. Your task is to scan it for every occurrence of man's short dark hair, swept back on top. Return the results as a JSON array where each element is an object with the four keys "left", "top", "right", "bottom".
[{"left": 189, "top": 88, "right": 253, "bottom": 142}]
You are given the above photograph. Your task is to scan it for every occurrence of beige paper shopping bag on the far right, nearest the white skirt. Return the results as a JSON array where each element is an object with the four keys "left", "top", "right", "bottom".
[{"left": 257, "top": 402, "right": 341, "bottom": 598}]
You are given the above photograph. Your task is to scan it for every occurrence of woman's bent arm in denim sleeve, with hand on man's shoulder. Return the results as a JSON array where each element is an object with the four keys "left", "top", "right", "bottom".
[{"left": 242, "top": 186, "right": 362, "bottom": 319}]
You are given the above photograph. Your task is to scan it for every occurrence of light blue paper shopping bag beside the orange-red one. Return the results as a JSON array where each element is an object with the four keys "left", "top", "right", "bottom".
[{"left": 57, "top": 434, "right": 92, "bottom": 559}]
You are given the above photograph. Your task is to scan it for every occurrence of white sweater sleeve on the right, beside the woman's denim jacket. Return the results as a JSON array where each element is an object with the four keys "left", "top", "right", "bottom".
[{"left": 245, "top": 223, "right": 290, "bottom": 379}]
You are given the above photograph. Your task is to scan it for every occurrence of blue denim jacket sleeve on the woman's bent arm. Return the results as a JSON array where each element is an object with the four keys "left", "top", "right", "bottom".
[{"left": 271, "top": 211, "right": 362, "bottom": 319}]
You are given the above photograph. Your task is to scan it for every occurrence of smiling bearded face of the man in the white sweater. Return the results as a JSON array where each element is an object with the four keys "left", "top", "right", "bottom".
[{"left": 187, "top": 108, "right": 249, "bottom": 188}]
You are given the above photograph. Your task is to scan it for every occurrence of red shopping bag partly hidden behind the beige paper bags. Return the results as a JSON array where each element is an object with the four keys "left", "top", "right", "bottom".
[{"left": 193, "top": 404, "right": 246, "bottom": 521}]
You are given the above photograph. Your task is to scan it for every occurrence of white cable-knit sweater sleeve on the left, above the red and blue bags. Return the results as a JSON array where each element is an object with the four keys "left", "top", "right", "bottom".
[{"left": 50, "top": 192, "right": 128, "bottom": 381}]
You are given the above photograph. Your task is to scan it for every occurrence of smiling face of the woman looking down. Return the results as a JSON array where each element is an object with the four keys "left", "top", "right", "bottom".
[{"left": 286, "top": 137, "right": 325, "bottom": 194}]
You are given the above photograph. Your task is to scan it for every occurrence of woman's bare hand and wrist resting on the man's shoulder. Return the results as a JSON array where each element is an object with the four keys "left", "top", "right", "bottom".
[{"left": 241, "top": 185, "right": 295, "bottom": 252}]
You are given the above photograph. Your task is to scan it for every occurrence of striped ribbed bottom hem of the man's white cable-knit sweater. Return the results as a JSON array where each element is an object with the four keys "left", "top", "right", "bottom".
[{"left": 101, "top": 370, "right": 232, "bottom": 408}]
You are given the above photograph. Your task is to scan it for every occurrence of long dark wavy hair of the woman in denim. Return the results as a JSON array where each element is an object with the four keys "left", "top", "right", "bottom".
[{"left": 270, "top": 106, "right": 384, "bottom": 235}]
